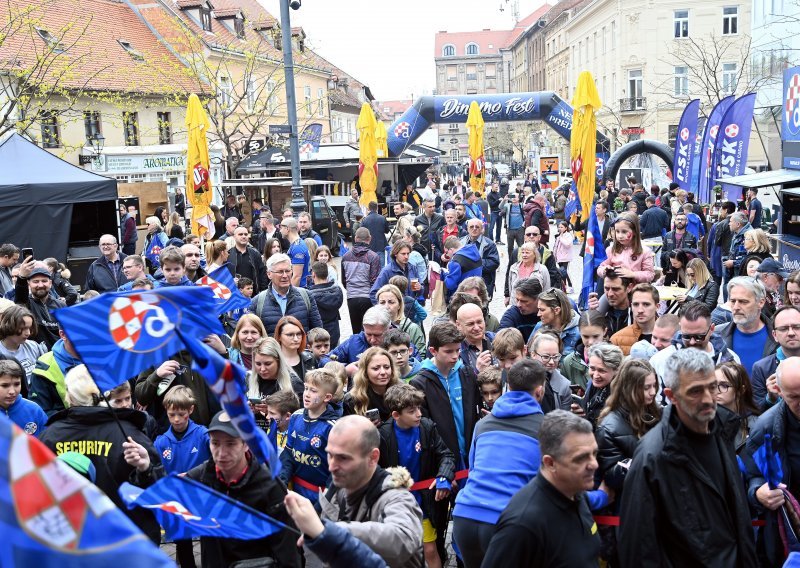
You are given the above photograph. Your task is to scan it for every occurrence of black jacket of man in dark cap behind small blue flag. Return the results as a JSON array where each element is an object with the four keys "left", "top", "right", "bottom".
[{"left": 186, "top": 455, "right": 301, "bottom": 568}]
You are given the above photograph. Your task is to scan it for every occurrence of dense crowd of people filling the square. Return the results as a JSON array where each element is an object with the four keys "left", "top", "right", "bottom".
[{"left": 0, "top": 174, "right": 800, "bottom": 568}]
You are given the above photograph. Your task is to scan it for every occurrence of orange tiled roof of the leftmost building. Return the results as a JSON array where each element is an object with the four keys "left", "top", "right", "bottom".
[{"left": 0, "top": 0, "right": 203, "bottom": 94}]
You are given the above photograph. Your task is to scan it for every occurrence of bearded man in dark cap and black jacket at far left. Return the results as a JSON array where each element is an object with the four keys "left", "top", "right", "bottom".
[{"left": 14, "top": 256, "right": 66, "bottom": 349}]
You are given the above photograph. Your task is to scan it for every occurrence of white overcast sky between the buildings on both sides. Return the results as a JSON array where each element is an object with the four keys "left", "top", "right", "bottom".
[{"left": 260, "top": 0, "right": 556, "bottom": 100}]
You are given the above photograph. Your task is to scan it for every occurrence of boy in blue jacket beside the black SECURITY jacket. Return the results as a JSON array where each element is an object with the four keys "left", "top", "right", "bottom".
[{"left": 153, "top": 385, "right": 211, "bottom": 566}]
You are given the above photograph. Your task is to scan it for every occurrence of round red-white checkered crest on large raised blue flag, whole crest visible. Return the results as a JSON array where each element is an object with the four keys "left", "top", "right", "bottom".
[{"left": 108, "top": 293, "right": 180, "bottom": 353}]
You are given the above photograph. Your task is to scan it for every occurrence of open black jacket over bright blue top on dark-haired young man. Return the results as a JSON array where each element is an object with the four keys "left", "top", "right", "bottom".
[{"left": 409, "top": 366, "right": 481, "bottom": 468}]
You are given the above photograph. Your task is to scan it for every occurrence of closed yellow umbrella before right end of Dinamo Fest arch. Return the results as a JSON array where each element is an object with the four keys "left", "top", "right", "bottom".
[{"left": 569, "top": 71, "right": 602, "bottom": 221}]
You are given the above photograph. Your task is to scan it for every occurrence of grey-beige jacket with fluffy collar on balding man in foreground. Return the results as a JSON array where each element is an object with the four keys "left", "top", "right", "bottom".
[{"left": 319, "top": 467, "right": 425, "bottom": 568}]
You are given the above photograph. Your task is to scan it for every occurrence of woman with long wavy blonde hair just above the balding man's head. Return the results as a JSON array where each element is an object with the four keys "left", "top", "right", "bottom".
[{"left": 343, "top": 347, "right": 400, "bottom": 426}]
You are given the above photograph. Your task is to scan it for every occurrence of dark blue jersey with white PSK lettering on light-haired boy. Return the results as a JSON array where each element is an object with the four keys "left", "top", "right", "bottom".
[{"left": 280, "top": 404, "right": 339, "bottom": 503}]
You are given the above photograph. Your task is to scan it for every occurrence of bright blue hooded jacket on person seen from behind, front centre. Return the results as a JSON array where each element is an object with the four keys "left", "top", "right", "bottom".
[{"left": 453, "top": 391, "right": 544, "bottom": 524}]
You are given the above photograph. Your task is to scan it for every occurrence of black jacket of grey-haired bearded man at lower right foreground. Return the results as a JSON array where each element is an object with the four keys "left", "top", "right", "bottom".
[{"left": 618, "top": 405, "right": 758, "bottom": 568}]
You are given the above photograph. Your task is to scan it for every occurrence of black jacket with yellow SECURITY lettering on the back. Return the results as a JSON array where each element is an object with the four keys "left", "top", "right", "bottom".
[{"left": 41, "top": 406, "right": 163, "bottom": 543}]
